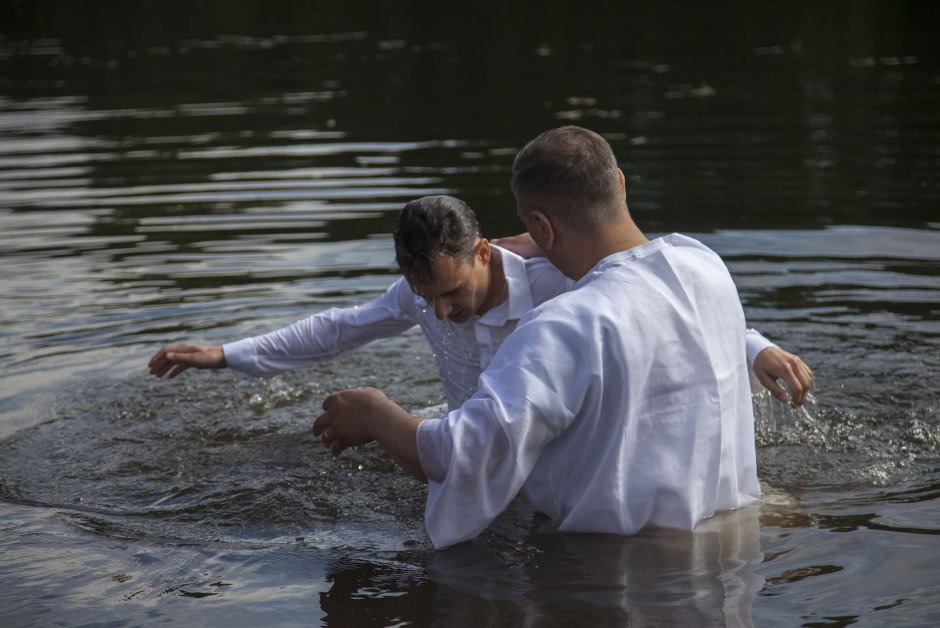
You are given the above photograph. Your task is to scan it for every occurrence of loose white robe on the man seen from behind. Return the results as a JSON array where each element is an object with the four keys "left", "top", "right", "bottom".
[{"left": 417, "top": 234, "right": 760, "bottom": 547}]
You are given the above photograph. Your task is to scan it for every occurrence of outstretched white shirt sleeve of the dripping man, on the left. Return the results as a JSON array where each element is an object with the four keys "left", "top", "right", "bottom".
[{"left": 222, "top": 279, "right": 416, "bottom": 377}]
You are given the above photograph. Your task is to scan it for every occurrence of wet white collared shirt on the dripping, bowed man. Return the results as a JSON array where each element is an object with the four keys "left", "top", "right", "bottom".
[{"left": 223, "top": 245, "right": 574, "bottom": 408}]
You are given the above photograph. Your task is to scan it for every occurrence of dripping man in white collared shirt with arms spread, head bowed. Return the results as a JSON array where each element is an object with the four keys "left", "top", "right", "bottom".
[{"left": 150, "top": 196, "right": 800, "bottom": 409}]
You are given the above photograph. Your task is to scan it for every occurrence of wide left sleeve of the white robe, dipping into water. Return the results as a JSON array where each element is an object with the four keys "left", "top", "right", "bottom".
[{"left": 417, "top": 314, "right": 590, "bottom": 548}]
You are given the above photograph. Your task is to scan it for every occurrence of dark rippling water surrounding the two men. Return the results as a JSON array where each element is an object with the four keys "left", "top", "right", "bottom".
[{"left": 0, "top": 1, "right": 940, "bottom": 626}]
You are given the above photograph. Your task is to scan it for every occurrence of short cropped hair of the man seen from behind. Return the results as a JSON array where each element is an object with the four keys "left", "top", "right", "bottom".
[{"left": 511, "top": 126, "right": 624, "bottom": 230}]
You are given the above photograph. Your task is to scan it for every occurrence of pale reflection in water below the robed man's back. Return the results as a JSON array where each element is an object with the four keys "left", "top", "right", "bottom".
[{"left": 429, "top": 507, "right": 763, "bottom": 626}]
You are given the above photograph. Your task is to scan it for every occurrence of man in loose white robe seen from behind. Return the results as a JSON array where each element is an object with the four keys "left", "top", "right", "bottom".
[{"left": 313, "top": 127, "right": 805, "bottom": 547}]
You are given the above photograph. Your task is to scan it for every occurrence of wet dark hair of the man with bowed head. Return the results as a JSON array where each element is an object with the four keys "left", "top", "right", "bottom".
[{"left": 392, "top": 195, "right": 480, "bottom": 284}]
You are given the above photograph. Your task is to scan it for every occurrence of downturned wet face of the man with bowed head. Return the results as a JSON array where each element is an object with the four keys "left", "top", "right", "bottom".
[{"left": 412, "top": 243, "right": 489, "bottom": 323}]
